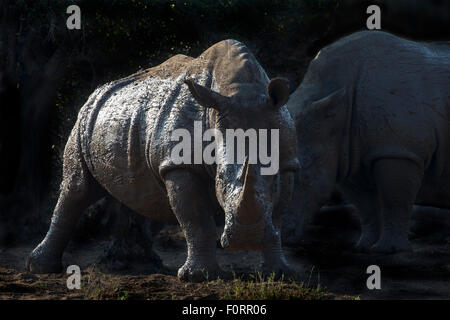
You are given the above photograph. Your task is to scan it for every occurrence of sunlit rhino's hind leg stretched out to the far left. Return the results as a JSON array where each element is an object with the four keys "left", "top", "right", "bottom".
[{"left": 26, "top": 134, "right": 104, "bottom": 273}]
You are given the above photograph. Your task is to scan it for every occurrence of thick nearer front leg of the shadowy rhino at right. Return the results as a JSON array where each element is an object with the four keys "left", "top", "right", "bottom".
[{"left": 372, "top": 159, "right": 423, "bottom": 253}]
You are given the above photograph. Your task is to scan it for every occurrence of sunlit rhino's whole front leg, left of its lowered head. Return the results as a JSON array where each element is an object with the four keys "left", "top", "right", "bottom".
[{"left": 164, "top": 169, "right": 222, "bottom": 282}]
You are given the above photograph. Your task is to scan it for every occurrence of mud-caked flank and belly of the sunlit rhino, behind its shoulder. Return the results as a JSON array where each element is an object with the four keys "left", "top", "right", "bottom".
[{"left": 75, "top": 55, "right": 192, "bottom": 220}]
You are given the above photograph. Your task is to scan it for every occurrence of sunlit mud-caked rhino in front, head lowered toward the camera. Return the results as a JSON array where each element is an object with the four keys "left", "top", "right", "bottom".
[{"left": 27, "top": 40, "right": 298, "bottom": 281}]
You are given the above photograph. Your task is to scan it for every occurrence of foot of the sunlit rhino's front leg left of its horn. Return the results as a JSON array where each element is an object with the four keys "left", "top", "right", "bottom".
[{"left": 178, "top": 261, "right": 225, "bottom": 282}]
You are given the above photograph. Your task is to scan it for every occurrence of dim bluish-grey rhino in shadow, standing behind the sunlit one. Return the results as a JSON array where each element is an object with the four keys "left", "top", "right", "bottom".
[{"left": 286, "top": 32, "right": 450, "bottom": 253}]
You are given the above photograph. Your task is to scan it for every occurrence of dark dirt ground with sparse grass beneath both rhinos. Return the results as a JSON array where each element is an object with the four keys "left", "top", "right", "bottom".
[{"left": 0, "top": 209, "right": 450, "bottom": 300}]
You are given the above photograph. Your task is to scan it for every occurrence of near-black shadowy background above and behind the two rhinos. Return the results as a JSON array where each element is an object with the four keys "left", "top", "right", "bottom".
[{"left": 0, "top": 0, "right": 450, "bottom": 245}]
